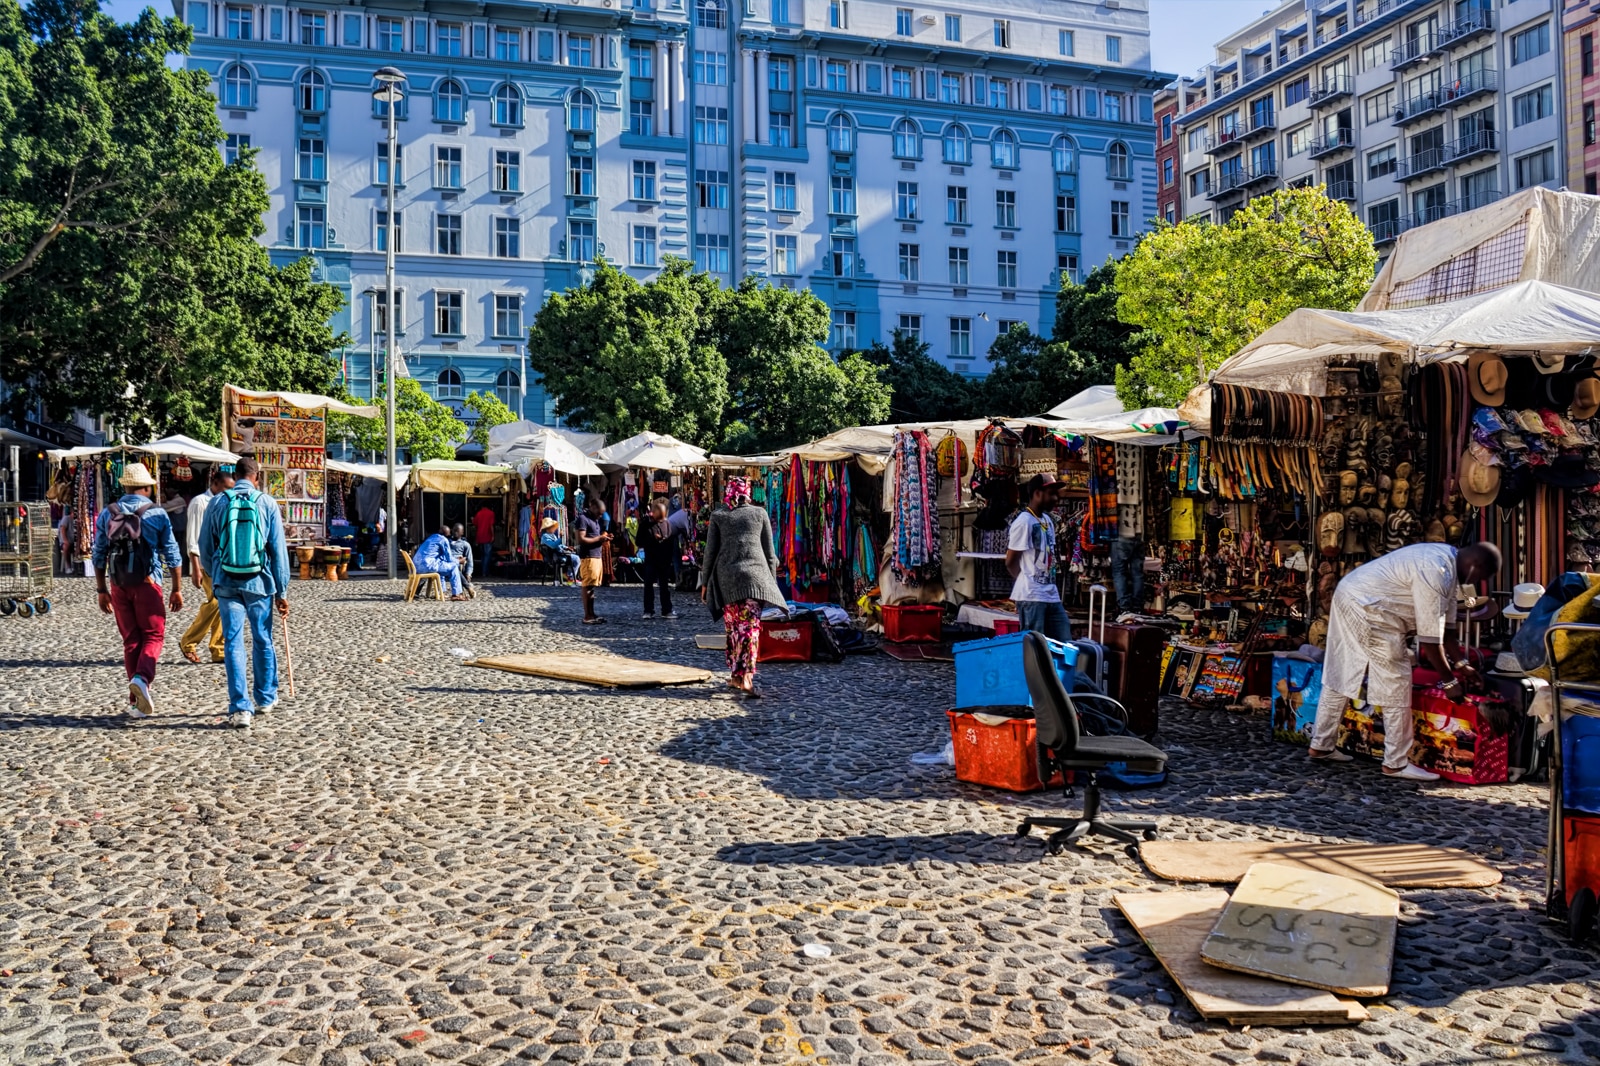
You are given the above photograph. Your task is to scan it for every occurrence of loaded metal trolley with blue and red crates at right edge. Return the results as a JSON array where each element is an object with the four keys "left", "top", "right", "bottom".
[{"left": 1544, "top": 623, "right": 1600, "bottom": 944}]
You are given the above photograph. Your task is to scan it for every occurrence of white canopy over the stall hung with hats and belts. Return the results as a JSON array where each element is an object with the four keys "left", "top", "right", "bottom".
[{"left": 1211, "top": 282, "right": 1600, "bottom": 395}]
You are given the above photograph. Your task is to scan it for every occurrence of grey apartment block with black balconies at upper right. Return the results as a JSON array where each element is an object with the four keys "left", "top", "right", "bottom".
[{"left": 1174, "top": 0, "right": 1566, "bottom": 251}]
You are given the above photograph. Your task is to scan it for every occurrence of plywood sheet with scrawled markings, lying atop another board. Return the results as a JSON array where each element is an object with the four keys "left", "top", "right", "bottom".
[{"left": 1200, "top": 863, "right": 1400, "bottom": 996}]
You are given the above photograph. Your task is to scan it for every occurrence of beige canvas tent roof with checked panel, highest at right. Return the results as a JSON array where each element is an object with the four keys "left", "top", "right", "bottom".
[{"left": 1358, "top": 189, "right": 1600, "bottom": 311}]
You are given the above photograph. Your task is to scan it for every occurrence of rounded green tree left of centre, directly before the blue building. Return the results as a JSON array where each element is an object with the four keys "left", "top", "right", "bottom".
[{"left": 528, "top": 258, "right": 728, "bottom": 445}]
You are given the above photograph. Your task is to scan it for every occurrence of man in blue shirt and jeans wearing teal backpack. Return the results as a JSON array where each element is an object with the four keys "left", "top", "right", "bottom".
[{"left": 200, "top": 456, "right": 290, "bottom": 730}]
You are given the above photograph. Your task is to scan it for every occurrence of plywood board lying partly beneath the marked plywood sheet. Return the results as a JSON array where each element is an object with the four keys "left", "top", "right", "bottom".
[{"left": 1114, "top": 892, "right": 1366, "bottom": 1026}]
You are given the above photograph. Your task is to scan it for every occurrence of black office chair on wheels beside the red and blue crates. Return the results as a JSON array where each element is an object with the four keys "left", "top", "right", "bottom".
[{"left": 1016, "top": 632, "right": 1166, "bottom": 858}]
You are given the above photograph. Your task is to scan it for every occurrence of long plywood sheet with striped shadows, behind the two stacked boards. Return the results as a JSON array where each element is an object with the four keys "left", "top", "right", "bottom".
[{"left": 1139, "top": 840, "right": 1501, "bottom": 888}]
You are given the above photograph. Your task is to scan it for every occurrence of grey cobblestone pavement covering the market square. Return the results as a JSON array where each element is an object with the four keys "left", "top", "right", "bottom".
[{"left": 0, "top": 581, "right": 1600, "bottom": 1066}]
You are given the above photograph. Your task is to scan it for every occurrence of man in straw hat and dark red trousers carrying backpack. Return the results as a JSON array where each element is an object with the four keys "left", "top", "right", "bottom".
[{"left": 93, "top": 463, "right": 184, "bottom": 719}]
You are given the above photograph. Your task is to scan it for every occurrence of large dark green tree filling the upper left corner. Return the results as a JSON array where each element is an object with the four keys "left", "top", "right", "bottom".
[{"left": 0, "top": 0, "right": 344, "bottom": 440}]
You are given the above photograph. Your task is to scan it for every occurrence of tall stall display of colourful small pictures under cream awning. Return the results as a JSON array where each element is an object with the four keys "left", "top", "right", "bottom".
[{"left": 222, "top": 386, "right": 379, "bottom": 546}]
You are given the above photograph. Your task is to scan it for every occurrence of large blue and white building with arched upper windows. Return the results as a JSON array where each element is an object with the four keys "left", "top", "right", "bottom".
[{"left": 174, "top": 0, "right": 1171, "bottom": 419}]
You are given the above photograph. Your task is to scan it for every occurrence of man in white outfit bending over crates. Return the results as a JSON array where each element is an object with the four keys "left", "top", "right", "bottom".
[{"left": 1310, "top": 543, "right": 1501, "bottom": 781}]
